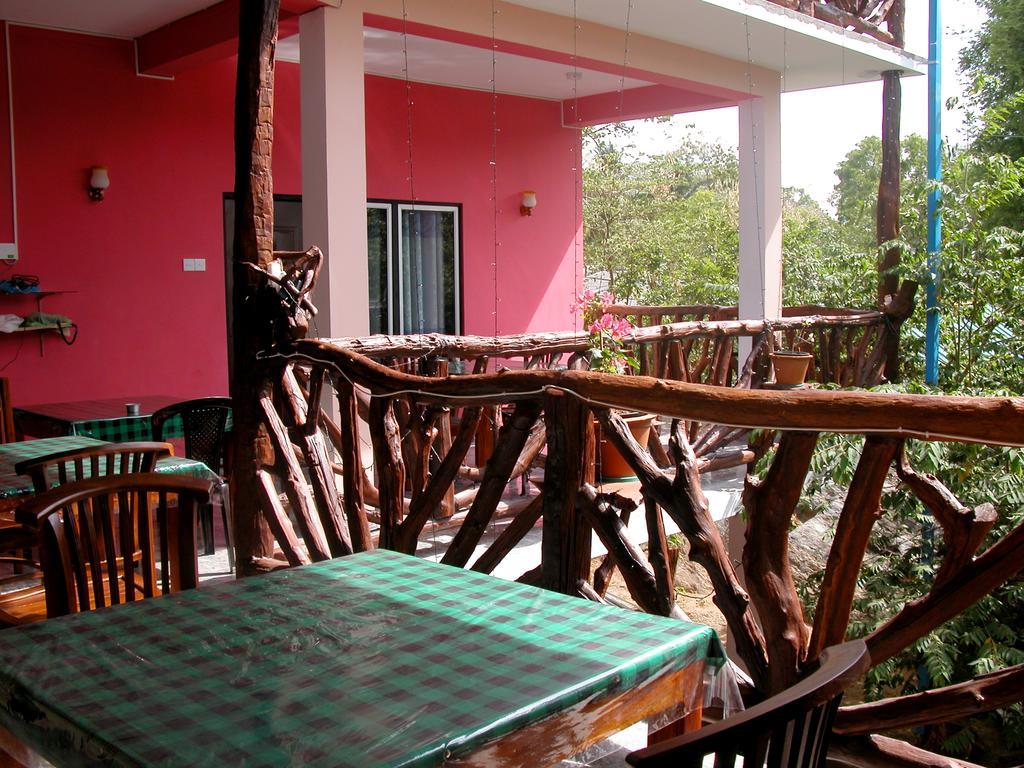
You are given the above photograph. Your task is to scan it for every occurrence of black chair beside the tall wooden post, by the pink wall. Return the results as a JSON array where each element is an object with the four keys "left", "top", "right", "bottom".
[{"left": 153, "top": 397, "right": 234, "bottom": 568}]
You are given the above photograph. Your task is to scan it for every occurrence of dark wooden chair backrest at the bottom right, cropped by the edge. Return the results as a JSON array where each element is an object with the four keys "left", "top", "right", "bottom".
[{"left": 626, "top": 640, "right": 870, "bottom": 768}]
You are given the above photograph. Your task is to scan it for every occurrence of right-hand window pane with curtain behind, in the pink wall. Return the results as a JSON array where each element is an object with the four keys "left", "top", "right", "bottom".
[{"left": 401, "top": 209, "right": 458, "bottom": 334}]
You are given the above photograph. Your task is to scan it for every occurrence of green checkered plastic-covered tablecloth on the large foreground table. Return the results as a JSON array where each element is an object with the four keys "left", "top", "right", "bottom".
[{"left": 0, "top": 550, "right": 722, "bottom": 768}]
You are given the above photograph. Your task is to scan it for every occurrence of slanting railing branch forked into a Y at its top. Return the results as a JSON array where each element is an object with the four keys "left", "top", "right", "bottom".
[{"left": 595, "top": 409, "right": 768, "bottom": 689}]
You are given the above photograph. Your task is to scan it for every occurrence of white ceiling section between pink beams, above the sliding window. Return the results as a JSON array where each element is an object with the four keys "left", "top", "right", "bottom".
[{"left": 278, "top": 28, "right": 650, "bottom": 100}]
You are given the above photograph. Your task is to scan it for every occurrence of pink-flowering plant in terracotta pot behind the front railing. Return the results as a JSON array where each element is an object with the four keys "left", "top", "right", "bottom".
[{"left": 572, "top": 291, "right": 654, "bottom": 480}]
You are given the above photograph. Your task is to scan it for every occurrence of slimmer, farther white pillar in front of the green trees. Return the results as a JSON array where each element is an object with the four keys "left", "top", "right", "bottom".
[{"left": 739, "top": 91, "right": 782, "bottom": 366}]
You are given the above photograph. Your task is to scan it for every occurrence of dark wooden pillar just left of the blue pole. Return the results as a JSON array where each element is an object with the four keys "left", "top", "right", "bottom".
[{"left": 876, "top": 70, "right": 902, "bottom": 381}]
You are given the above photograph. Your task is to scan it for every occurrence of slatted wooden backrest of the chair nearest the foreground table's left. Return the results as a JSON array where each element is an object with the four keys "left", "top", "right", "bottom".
[{"left": 20, "top": 472, "right": 211, "bottom": 618}]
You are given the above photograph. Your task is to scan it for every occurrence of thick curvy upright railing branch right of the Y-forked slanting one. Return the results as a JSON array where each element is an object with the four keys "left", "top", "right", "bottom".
[{"left": 743, "top": 432, "right": 818, "bottom": 693}]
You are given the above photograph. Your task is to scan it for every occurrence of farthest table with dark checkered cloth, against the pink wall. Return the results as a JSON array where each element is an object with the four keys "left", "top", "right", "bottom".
[{"left": 14, "top": 394, "right": 182, "bottom": 442}]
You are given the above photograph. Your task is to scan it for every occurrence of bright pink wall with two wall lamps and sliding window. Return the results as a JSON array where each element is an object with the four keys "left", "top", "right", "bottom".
[{"left": 0, "top": 26, "right": 582, "bottom": 403}]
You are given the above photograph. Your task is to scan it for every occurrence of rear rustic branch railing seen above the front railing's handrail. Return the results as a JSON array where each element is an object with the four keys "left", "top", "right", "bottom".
[{"left": 327, "top": 305, "right": 889, "bottom": 386}]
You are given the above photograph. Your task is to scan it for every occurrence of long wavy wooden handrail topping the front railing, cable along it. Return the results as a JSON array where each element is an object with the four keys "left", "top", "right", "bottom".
[{"left": 288, "top": 340, "right": 1024, "bottom": 445}]
